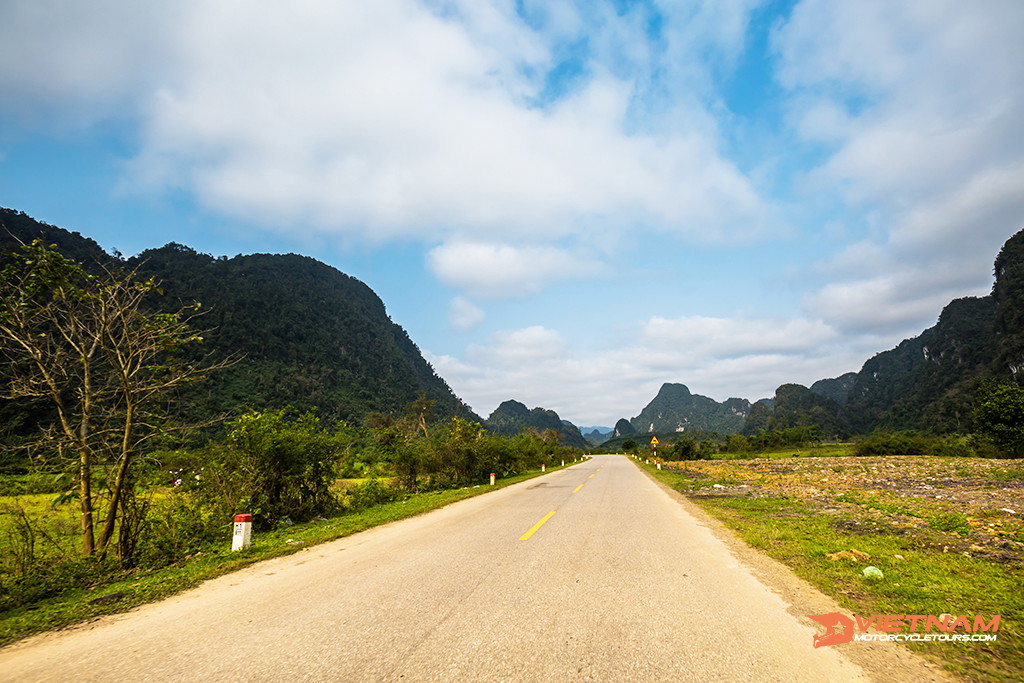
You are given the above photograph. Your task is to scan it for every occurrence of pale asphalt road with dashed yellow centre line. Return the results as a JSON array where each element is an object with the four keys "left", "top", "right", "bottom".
[{"left": 0, "top": 456, "right": 913, "bottom": 683}]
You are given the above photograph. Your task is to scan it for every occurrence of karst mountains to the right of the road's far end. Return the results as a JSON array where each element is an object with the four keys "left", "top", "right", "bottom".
[{"left": 613, "top": 230, "right": 1024, "bottom": 436}]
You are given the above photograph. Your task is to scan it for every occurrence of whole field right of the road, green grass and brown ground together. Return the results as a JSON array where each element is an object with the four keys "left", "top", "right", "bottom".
[{"left": 641, "top": 451, "right": 1024, "bottom": 681}]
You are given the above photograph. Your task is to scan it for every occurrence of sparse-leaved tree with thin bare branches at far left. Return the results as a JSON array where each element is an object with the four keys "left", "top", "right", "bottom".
[{"left": 0, "top": 240, "right": 224, "bottom": 560}]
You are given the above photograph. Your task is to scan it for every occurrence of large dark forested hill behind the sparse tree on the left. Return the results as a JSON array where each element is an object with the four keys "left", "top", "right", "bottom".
[{"left": 0, "top": 209, "right": 480, "bottom": 438}]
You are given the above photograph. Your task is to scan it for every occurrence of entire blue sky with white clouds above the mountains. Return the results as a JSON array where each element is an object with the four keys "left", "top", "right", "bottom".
[{"left": 0, "top": 0, "right": 1024, "bottom": 426}]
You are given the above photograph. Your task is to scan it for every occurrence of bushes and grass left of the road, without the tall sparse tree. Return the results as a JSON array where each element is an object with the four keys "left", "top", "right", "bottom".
[{"left": 0, "top": 402, "right": 582, "bottom": 644}]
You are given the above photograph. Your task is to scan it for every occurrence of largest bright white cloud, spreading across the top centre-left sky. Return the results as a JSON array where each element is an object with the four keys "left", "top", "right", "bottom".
[{"left": 94, "top": 0, "right": 769, "bottom": 248}]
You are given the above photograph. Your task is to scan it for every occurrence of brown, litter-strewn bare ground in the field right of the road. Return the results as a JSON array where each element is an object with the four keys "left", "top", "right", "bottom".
[{"left": 666, "top": 456, "right": 1024, "bottom": 563}]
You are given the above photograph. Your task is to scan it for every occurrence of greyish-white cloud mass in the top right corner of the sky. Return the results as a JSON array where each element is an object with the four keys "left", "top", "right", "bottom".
[{"left": 774, "top": 0, "right": 1024, "bottom": 334}]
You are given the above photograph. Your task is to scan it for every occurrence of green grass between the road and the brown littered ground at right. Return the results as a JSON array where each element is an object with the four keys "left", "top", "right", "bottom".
[{"left": 641, "top": 463, "right": 1024, "bottom": 681}]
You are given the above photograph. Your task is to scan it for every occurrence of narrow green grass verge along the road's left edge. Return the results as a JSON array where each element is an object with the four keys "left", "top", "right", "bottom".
[{"left": 0, "top": 467, "right": 577, "bottom": 645}]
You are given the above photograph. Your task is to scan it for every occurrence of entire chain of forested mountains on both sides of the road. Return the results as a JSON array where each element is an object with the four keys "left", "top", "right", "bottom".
[{"left": 8, "top": 209, "right": 1024, "bottom": 449}]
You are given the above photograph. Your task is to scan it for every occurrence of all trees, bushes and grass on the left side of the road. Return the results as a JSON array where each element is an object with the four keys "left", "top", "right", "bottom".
[{"left": 0, "top": 240, "right": 580, "bottom": 643}]
